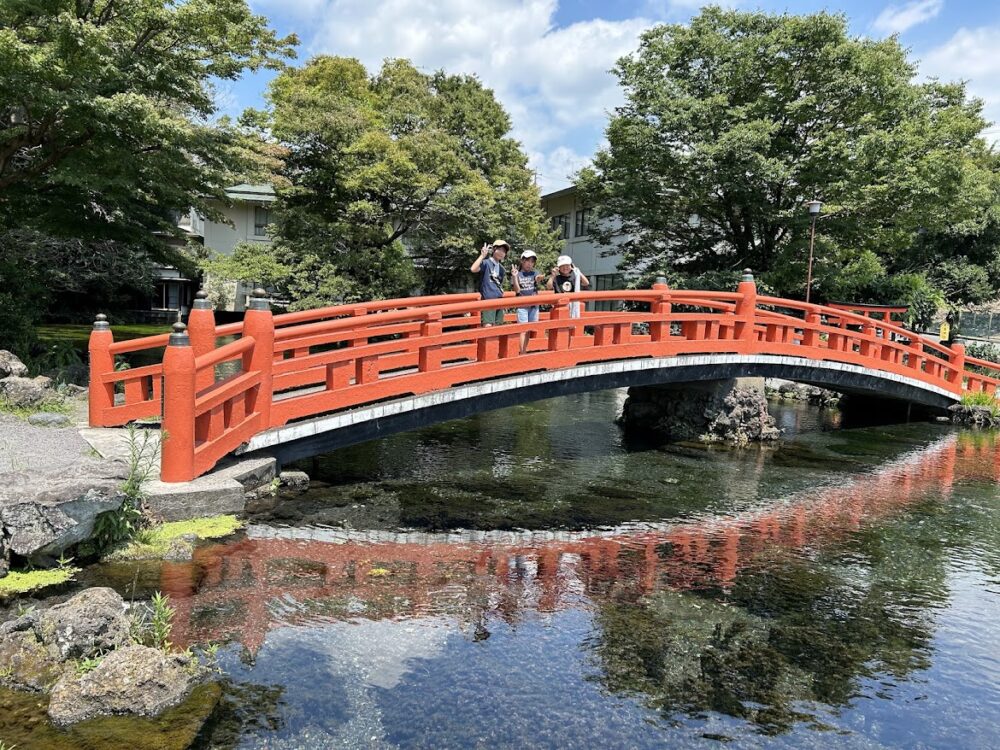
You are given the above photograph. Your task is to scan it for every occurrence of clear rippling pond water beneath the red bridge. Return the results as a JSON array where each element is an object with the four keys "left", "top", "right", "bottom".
[{"left": 0, "top": 391, "right": 1000, "bottom": 750}]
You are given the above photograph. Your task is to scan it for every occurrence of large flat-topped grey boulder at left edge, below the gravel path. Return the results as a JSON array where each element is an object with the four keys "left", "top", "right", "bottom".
[{"left": 0, "top": 460, "right": 127, "bottom": 563}]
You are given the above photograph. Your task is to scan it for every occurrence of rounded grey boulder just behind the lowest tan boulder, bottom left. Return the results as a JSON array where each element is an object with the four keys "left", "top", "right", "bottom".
[{"left": 38, "top": 588, "right": 130, "bottom": 659}]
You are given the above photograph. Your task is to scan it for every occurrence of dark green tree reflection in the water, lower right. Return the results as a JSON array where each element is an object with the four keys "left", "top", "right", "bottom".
[{"left": 586, "top": 504, "right": 948, "bottom": 733}]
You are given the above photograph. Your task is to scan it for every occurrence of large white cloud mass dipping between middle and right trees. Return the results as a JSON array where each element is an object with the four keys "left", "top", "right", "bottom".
[{"left": 256, "top": 0, "right": 650, "bottom": 194}]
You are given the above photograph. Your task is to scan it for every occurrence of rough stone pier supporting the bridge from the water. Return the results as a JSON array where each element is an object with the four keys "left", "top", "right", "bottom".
[{"left": 619, "top": 378, "right": 781, "bottom": 446}]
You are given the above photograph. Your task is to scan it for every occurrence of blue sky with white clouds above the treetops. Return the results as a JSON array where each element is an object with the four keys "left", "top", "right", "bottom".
[{"left": 227, "top": 0, "right": 1000, "bottom": 192}]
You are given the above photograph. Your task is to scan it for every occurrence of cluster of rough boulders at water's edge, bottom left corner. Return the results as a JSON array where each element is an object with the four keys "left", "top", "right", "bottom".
[{"left": 0, "top": 588, "right": 209, "bottom": 726}]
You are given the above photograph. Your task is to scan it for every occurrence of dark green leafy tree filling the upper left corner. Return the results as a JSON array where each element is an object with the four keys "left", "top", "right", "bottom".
[{"left": 0, "top": 0, "right": 295, "bottom": 351}]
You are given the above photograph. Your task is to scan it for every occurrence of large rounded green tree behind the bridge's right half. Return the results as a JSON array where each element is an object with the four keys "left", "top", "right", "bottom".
[{"left": 580, "top": 7, "right": 998, "bottom": 301}]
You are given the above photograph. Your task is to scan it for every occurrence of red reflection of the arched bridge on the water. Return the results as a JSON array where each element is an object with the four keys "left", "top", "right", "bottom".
[{"left": 161, "top": 434, "right": 1000, "bottom": 653}]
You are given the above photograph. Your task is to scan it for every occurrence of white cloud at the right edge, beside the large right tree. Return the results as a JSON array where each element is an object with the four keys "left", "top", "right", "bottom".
[{"left": 920, "top": 26, "right": 1000, "bottom": 140}]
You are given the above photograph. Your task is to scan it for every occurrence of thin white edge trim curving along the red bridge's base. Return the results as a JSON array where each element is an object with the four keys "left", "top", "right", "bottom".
[{"left": 236, "top": 354, "right": 959, "bottom": 453}]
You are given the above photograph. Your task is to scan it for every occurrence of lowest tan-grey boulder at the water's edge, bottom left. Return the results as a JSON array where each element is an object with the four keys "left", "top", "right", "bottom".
[{"left": 49, "top": 646, "right": 204, "bottom": 726}]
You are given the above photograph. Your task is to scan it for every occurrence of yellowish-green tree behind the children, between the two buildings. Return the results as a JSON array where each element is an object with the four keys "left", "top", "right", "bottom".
[{"left": 260, "top": 56, "right": 557, "bottom": 307}]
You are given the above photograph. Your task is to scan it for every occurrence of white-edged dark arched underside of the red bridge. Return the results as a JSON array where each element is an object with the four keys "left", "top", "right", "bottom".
[{"left": 238, "top": 354, "right": 958, "bottom": 470}]
